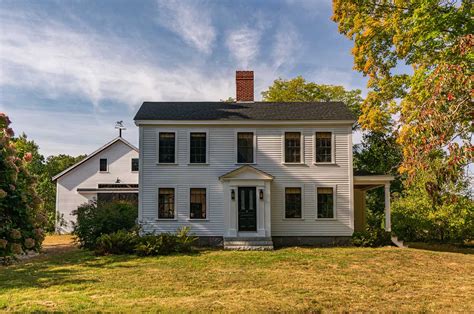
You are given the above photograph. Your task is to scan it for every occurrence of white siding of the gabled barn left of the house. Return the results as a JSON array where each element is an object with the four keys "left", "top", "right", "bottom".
[{"left": 56, "top": 141, "right": 138, "bottom": 232}]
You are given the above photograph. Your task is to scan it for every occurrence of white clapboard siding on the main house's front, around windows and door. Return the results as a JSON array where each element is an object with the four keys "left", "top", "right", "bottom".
[{"left": 140, "top": 125, "right": 353, "bottom": 236}]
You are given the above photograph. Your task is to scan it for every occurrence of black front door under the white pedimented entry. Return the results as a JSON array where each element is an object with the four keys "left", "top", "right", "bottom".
[{"left": 239, "top": 187, "right": 257, "bottom": 231}]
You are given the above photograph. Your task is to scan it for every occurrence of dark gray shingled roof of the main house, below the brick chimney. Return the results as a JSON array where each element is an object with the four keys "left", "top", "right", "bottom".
[{"left": 134, "top": 102, "right": 355, "bottom": 121}]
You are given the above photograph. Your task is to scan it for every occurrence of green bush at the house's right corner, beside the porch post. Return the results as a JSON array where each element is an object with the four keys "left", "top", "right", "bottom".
[{"left": 352, "top": 210, "right": 392, "bottom": 247}]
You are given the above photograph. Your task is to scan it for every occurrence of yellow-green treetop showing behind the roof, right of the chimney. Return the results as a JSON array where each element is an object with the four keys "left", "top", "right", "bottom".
[{"left": 262, "top": 76, "right": 363, "bottom": 117}]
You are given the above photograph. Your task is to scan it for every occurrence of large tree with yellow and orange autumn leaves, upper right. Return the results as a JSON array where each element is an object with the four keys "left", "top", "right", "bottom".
[{"left": 332, "top": 0, "right": 474, "bottom": 208}]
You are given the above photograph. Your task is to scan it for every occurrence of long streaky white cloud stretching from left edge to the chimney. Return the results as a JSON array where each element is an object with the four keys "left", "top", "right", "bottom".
[{"left": 0, "top": 14, "right": 233, "bottom": 108}]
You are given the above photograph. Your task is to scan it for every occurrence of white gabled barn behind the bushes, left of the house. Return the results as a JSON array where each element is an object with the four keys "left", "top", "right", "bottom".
[{"left": 52, "top": 136, "right": 139, "bottom": 233}]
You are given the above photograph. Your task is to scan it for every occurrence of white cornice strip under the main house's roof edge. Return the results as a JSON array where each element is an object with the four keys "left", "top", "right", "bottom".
[{"left": 135, "top": 120, "right": 356, "bottom": 126}]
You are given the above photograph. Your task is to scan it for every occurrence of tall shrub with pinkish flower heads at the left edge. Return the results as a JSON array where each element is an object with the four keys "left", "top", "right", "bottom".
[{"left": 0, "top": 113, "right": 46, "bottom": 262}]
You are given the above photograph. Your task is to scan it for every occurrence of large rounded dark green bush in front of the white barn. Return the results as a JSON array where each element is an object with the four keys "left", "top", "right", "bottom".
[{"left": 72, "top": 201, "right": 138, "bottom": 249}]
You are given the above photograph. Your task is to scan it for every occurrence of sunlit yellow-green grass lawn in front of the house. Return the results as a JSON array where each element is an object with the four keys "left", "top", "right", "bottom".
[{"left": 0, "top": 237, "right": 474, "bottom": 312}]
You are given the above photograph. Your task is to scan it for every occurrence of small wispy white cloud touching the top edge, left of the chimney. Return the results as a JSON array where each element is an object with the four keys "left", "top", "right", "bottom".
[{"left": 157, "top": 0, "right": 216, "bottom": 54}]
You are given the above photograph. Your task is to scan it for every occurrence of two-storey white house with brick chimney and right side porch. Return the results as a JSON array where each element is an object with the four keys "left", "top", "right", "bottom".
[{"left": 135, "top": 71, "right": 392, "bottom": 249}]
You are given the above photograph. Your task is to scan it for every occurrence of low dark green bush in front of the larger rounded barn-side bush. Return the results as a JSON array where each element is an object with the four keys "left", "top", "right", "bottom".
[{"left": 95, "top": 230, "right": 139, "bottom": 255}]
